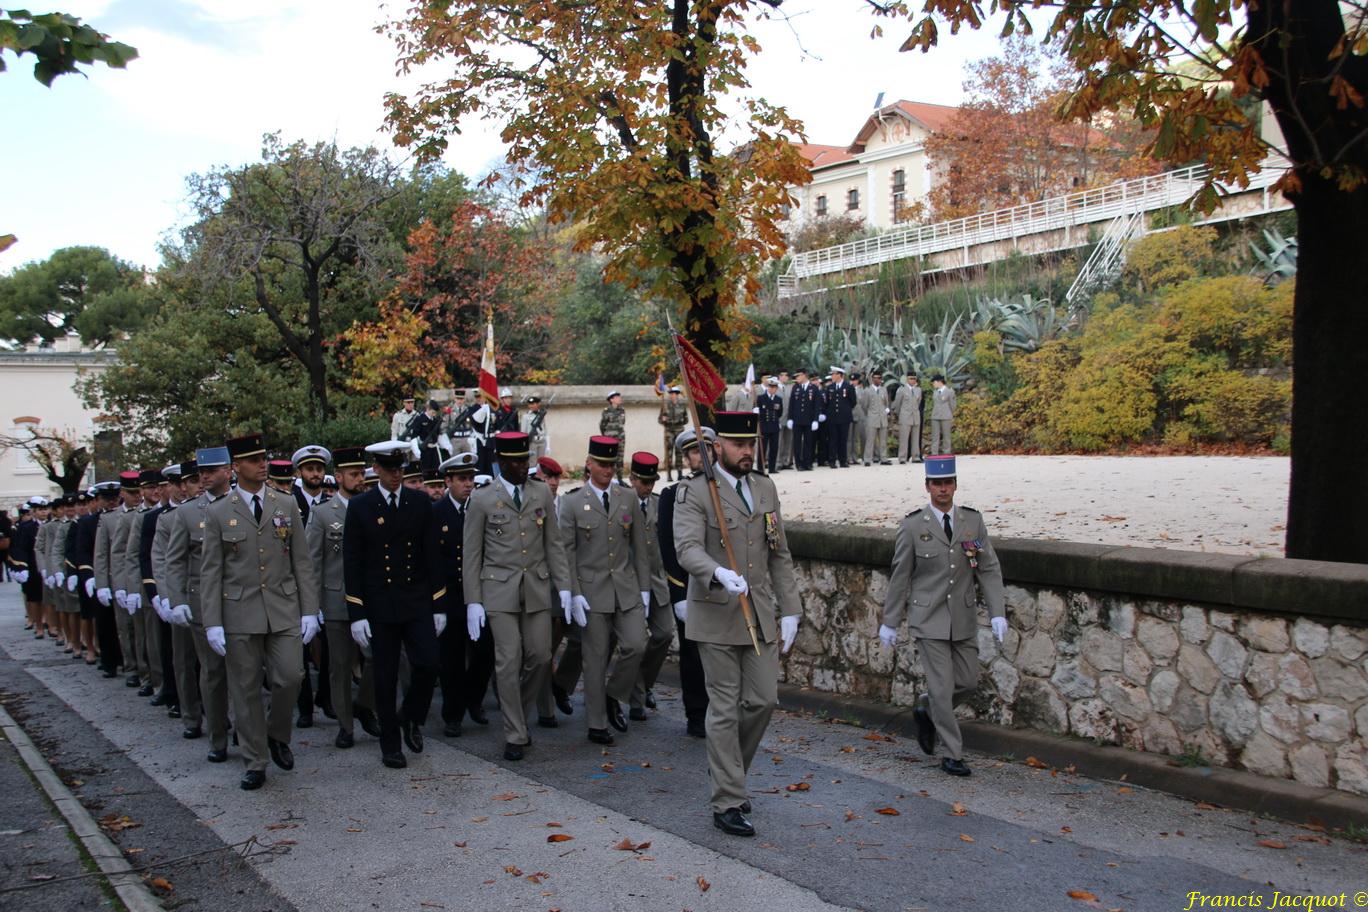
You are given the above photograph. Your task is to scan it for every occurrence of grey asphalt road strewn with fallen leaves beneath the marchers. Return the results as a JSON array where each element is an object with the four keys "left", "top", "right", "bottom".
[{"left": 0, "top": 587, "right": 1368, "bottom": 912}]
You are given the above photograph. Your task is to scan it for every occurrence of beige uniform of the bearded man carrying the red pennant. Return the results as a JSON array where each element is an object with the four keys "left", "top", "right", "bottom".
[{"left": 674, "top": 470, "right": 802, "bottom": 814}]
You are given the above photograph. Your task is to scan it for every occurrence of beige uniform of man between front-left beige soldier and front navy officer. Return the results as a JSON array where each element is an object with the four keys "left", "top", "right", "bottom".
[{"left": 305, "top": 494, "right": 375, "bottom": 732}]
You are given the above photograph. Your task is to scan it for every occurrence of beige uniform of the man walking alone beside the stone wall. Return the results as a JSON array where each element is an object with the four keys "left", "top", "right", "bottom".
[{"left": 884, "top": 506, "right": 1007, "bottom": 760}]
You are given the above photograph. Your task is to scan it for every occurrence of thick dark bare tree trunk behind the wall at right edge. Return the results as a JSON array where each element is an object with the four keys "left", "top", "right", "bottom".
[{"left": 1287, "top": 172, "right": 1368, "bottom": 563}]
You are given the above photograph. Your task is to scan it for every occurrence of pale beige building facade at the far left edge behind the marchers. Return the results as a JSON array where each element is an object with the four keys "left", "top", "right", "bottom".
[{"left": 0, "top": 336, "right": 114, "bottom": 509}]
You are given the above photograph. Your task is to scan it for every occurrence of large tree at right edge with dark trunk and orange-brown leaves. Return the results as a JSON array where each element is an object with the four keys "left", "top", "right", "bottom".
[{"left": 873, "top": 0, "right": 1368, "bottom": 563}]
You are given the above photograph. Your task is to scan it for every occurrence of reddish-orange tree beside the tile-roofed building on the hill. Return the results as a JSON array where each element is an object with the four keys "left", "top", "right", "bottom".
[{"left": 926, "top": 36, "right": 1159, "bottom": 219}]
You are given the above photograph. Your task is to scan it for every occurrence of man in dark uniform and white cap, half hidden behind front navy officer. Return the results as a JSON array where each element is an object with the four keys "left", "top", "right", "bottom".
[{"left": 432, "top": 453, "right": 494, "bottom": 738}]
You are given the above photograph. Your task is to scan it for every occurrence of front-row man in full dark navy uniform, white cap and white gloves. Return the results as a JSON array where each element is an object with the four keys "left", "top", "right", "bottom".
[{"left": 342, "top": 440, "right": 446, "bottom": 770}]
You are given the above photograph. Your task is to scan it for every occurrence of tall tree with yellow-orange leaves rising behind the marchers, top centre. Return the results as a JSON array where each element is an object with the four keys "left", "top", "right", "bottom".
[{"left": 382, "top": 0, "right": 807, "bottom": 361}]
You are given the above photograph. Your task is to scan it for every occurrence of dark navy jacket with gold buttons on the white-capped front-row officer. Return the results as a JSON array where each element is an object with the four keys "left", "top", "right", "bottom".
[{"left": 342, "top": 485, "right": 447, "bottom": 623}]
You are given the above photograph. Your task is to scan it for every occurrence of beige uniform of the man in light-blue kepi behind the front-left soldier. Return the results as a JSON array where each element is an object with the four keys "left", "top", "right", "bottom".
[{"left": 157, "top": 491, "right": 228, "bottom": 751}]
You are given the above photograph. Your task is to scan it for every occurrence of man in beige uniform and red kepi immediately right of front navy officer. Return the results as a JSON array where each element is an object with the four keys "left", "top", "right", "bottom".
[{"left": 461, "top": 432, "right": 571, "bottom": 760}]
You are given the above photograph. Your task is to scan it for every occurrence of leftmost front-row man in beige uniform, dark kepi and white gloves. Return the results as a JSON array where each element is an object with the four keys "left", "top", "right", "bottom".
[{"left": 200, "top": 433, "right": 319, "bottom": 790}]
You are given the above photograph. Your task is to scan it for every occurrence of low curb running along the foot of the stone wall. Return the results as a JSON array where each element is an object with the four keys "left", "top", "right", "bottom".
[{"left": 771, "top": 675, "right": 1368, "bottom": 830}]
